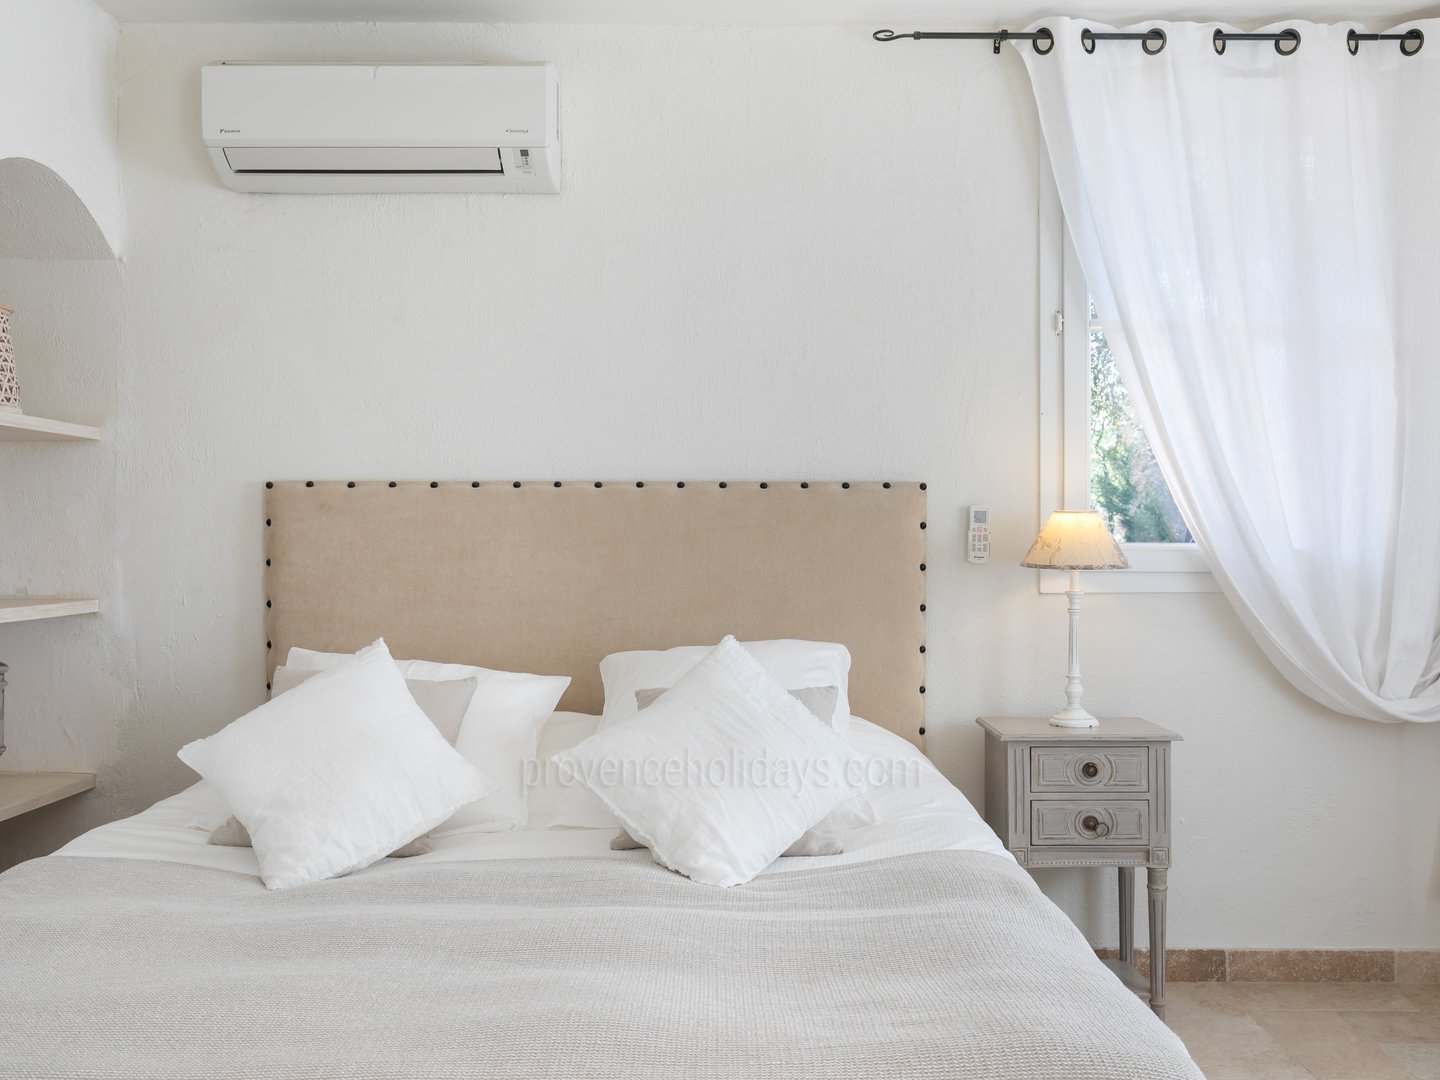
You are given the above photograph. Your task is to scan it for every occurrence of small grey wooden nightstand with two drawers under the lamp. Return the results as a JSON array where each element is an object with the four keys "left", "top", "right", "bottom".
[{"left": 975, "top": 716, "right": 1181, "bottom": 1020}]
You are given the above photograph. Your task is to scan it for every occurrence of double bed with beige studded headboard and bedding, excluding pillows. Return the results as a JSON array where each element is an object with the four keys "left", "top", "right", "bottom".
[{"left": 0, "top": 481, "right": 1200, "bottom": 1080}]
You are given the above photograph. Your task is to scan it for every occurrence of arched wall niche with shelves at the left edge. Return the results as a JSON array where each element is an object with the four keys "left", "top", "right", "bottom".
[{"left": 0, "top": 156, "right": 123, "bottom": 870}]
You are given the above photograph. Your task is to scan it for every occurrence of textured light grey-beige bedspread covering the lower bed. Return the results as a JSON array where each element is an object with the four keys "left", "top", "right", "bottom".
[{"left": 0, "top": 851, "right": 1200, "bottom": 1080}]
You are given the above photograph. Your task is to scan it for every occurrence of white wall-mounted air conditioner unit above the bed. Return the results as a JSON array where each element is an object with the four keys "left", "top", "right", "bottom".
[{"left": 200, "top": 63, "right": 560, "bottom": 192}]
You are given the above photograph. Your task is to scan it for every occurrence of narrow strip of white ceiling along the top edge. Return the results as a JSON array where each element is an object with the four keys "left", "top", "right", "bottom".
[{"left": 87, "top": 0, "right": 1440, "bottom": 30}]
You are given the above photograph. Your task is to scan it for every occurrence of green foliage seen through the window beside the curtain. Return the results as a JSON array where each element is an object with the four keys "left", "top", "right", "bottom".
[{"left": 1090, "top": 328, "right": 1191, "bottom": 543}]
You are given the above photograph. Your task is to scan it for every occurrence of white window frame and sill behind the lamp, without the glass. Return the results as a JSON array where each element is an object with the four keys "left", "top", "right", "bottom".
[{"left": 1035, "top": 148, "right": 1220, "bottom": 593}]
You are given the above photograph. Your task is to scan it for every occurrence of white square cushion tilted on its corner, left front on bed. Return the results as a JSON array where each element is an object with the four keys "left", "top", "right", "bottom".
[{"left": 179, "top": 641, "right": 490, "bottom": 888}]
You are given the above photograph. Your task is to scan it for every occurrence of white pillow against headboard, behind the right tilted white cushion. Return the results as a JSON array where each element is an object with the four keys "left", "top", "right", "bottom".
[{"left": 600, "top": 639, "right": 850, "bottom": 734}]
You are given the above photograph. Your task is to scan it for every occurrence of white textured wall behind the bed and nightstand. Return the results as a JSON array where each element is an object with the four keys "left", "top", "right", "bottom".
[{"left": 0, "top": 14, "right": 1440, "bottom": 948}]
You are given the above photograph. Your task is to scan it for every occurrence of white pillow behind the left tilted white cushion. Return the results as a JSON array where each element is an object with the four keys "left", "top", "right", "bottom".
[{"left": 285, "top": 648, "right": 570, "bottom": 832}]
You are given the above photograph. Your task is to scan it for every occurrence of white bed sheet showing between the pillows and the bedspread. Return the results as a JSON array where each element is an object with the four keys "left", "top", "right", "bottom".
[{"left": 55, "top": 717, "right": 1011, "bottom": 878}]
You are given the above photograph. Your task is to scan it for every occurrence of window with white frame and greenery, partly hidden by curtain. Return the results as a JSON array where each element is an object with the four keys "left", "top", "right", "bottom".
[{"left": 1037, "top": 160, "right": 1217, "bottom": 592}]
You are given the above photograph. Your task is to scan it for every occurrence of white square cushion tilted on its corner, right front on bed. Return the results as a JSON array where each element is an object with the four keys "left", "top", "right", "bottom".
[{"left": 557, "top": 638, "right": 870, "bottom": 886}]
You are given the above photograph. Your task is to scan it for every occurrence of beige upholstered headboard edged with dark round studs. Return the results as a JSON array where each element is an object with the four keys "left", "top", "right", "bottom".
[{"left": 265, "top": 481, "right": 926, "bottom": 744}]
